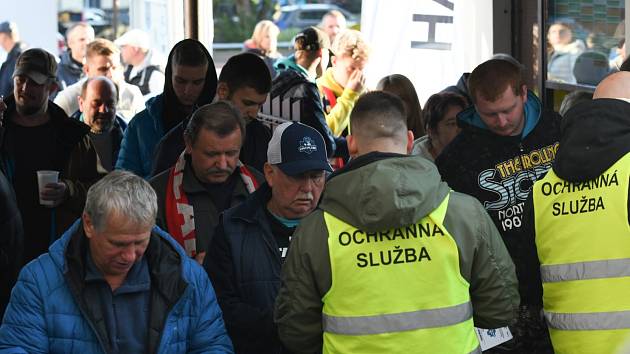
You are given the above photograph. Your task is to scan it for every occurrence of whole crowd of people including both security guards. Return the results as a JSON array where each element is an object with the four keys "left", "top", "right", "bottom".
[{"left": 0, "top": 11, "right": 630, "bottom": 354}]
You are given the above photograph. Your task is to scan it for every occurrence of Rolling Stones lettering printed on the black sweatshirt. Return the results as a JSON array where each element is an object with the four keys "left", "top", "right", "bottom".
[{"left": 478, "top": 143, "right": 559, "bottom": 231}]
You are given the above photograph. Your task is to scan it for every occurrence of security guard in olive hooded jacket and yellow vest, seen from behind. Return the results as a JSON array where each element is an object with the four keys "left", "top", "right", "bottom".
[{"left": 278, "top": 91, "right": 518, "bottom": 354}]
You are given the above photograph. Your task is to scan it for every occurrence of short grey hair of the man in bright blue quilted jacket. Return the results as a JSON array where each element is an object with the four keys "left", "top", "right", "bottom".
[{"left": 83, "top": 171, "right": 157, "bottom": 231}]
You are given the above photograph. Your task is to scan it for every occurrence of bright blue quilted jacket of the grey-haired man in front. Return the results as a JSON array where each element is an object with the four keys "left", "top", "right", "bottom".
[{"left": 0, "top": 221, "right": 233, "bottom": 354}]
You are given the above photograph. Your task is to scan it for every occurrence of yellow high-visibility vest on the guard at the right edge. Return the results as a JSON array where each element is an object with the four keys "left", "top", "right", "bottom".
[{"left": 533, "top": 154, "right": 630, "bottom": 354}]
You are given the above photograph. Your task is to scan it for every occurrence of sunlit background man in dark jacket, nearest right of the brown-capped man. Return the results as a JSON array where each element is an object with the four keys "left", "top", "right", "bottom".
[{"left": 57, "top": 22, "right": 94, "bottom": 90}]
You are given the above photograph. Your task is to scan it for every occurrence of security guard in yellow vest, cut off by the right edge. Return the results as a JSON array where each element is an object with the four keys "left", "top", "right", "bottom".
[{"left": 521, "top": 72, "right": 630, "bottom": 353}]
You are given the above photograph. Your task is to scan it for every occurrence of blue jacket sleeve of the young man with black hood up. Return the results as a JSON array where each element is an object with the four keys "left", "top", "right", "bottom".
[{"left": 116, "top": 94, "right": 165, "bottom": 179}]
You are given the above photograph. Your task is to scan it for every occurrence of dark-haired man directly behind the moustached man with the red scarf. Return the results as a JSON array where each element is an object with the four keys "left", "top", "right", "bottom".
[{"left": 151, "top": 53, "right": 271, "bottom": 175}]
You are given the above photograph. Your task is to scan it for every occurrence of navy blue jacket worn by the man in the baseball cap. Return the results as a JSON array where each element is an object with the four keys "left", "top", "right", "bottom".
[{"left": 205, "top": 183, "right": 282, "bottom": 354}]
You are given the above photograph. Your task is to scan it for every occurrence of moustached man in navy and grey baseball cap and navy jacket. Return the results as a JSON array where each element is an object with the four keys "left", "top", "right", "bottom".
[{"left": 205, "top": 122, "right": 332, "bottom": 354}]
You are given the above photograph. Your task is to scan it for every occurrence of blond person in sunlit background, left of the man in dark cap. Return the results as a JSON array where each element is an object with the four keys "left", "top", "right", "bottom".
[{"left": 245, "top": 20, "right": 282, "bottom": 78}]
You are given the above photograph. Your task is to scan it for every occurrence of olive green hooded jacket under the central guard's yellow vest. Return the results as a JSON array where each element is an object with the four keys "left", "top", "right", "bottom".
[{"left": 275, "top": 153, "right": 519, "bottom": 353}]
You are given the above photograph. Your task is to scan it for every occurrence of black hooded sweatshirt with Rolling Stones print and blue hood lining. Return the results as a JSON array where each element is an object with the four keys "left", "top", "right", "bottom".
[{"left": 435, "top": 91, "right": 560, "bottom": 278}]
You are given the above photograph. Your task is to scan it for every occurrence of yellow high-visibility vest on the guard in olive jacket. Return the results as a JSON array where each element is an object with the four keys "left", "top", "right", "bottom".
[{"left": 322, "top": 195, "right": 481, "bottom": 354}]
